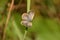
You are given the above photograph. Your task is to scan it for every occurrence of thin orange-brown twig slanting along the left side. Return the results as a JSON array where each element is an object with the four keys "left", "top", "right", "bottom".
[{"left": 2, "top": 0, "right": 14, "bottom": 40}]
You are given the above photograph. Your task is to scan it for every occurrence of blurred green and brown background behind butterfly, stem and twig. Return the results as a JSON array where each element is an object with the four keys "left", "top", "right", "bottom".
[{"left": 0, "top": 0, "right": 60, "bottom": 40}]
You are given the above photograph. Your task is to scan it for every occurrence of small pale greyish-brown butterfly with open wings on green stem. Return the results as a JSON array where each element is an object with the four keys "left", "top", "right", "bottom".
[{"left": 21, "top": 11, "right": 34, "bottom": 27}]
